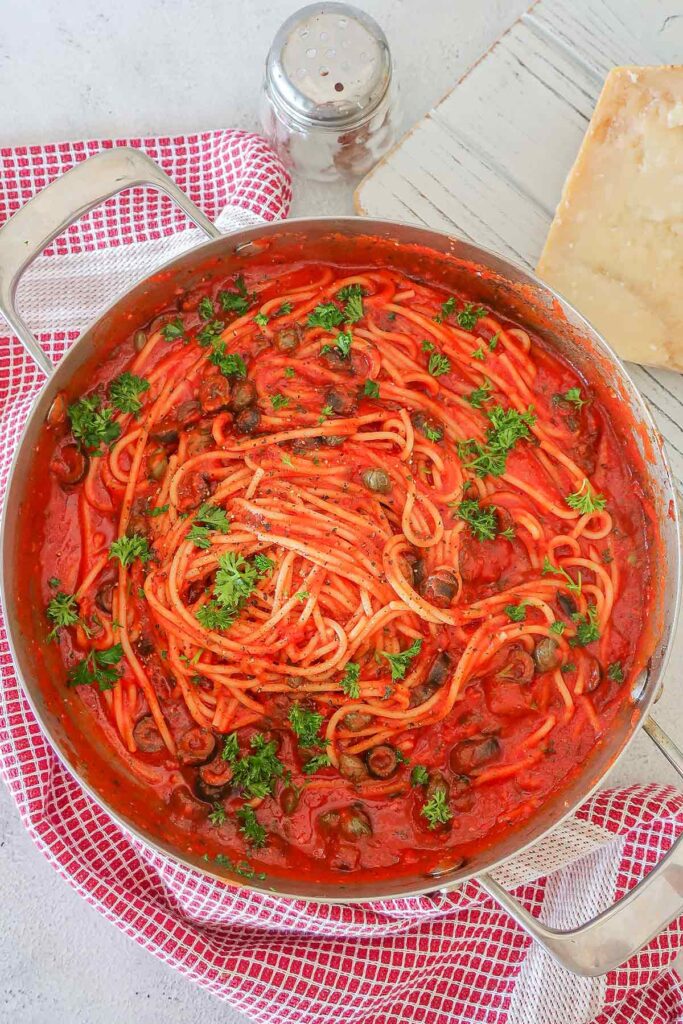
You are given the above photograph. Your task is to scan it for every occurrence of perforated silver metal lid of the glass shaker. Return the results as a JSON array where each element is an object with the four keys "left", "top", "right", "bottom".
[{"left": 266, "top": 3, "right": 391, "bottom": 128}]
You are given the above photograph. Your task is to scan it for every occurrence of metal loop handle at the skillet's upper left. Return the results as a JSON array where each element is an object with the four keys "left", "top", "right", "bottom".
[{"left": 0, "top": 146, "right": 220, "bottom": 375}]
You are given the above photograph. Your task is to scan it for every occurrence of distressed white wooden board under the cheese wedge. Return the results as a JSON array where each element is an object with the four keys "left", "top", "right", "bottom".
[{"left": 355, "top": 0, "right": 683, "bottom": 487}]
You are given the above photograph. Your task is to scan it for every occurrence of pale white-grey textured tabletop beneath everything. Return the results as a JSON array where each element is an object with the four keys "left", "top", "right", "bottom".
[{"left": 0, "top": 0, "right": 683, "bottom": 1024}]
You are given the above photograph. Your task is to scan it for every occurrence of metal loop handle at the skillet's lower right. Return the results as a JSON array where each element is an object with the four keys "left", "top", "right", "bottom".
[{"left": 478, "top": 718, "right": 683, "bottom": 978}]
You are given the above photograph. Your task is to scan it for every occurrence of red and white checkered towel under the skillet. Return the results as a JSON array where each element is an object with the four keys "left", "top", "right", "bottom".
[{"left": 0, "top": 131, "right": 683, "bottom": 1024}]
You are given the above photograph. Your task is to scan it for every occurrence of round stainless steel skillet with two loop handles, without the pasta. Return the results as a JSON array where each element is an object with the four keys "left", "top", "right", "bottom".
[{"left": 0, "top": 148, "right": 683, "bottom": 975}]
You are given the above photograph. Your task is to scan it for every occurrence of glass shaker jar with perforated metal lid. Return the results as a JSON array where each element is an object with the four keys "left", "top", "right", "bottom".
[{"left": 261, "top": 3, "right": 397, "bottom": 181}]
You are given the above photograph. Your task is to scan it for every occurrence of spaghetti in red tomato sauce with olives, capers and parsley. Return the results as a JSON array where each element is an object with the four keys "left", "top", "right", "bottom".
[{"left": 38, "top": 264, "right": 649, "bottom": 871}]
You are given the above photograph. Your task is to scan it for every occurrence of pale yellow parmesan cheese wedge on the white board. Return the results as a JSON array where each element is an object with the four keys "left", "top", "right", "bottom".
[{"left": 538, "top": 67, "right": 683, "bottom": 371}]
